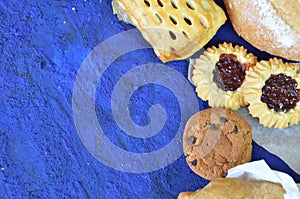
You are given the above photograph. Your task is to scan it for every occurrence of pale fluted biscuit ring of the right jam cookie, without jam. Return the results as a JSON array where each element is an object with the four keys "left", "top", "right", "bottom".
[{"left": 244, "top": 58, "right": 300, "bottom": 129}]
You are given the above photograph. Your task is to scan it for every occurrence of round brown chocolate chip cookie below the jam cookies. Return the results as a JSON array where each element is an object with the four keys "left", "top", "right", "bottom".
[{"left": 183, "top": 108, "right": 252, "bottom": 180}]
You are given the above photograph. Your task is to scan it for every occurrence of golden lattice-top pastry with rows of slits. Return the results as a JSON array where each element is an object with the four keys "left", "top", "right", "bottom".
[{"left": 113, "top": 0, "right": 226, "bottom": 62}]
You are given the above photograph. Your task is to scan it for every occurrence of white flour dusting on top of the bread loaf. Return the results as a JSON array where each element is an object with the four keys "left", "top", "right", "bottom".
[{"left": 247, "top": 0, "right": 300, "bottom": 48}]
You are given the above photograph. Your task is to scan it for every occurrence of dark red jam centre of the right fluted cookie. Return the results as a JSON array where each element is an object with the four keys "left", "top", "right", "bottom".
[{"left": 261, "top": 73, "right": 300, "bottom": 112}]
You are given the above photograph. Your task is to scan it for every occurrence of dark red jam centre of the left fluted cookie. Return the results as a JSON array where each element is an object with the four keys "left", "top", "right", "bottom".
[{"left": 213, "top": 54, "right": 250, "bottom": 91}]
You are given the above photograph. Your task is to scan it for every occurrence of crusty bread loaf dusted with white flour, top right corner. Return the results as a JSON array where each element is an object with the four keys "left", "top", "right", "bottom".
[{"left": 224, "top": 0, "right": 300, "bottom": 61}]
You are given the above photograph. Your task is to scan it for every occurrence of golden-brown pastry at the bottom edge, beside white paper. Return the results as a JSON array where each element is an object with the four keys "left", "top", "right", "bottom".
[{"left": 178, "top": 178, "right": 285, "bottom": 199}]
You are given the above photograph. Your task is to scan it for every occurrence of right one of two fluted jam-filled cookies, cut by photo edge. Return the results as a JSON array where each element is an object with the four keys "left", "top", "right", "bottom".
[{"left": 244, "top": 58, "right": 300, "bottom": 129}]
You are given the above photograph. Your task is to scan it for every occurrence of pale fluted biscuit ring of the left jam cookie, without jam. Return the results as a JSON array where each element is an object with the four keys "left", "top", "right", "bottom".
[{"left": 190, "top": 42, "right": 257, "bottom": 110}]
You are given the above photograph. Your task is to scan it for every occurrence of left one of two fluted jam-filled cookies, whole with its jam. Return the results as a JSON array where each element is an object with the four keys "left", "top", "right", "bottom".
[{"left": 190, "top": 42, "right": 257, "bottom": 110}]
